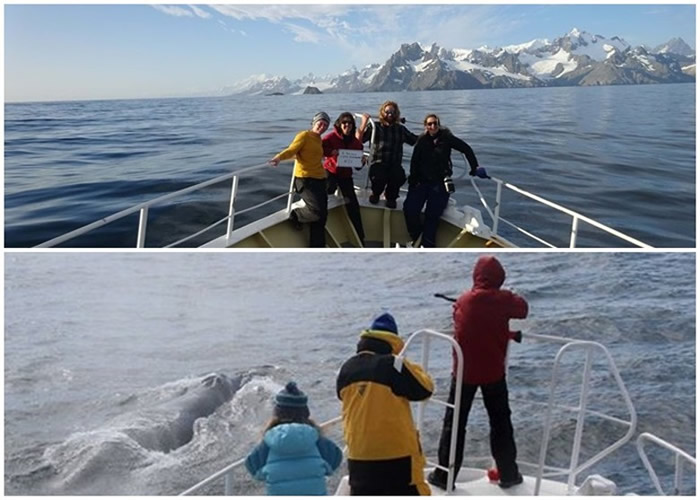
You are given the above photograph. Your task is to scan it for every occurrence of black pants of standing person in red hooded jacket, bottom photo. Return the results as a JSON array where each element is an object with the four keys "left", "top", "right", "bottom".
[{"left": 436, "top": 378, "right": 518, "bottom": 482}]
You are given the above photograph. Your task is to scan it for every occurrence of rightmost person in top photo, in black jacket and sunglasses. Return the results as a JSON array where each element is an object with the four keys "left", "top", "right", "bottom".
[{"left": 403, "top": 114, "right": 479, "bottom": 248}]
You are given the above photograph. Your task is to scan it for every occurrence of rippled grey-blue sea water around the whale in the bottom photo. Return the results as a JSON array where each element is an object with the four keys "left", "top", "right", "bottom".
[{"left": 4, "top": 252, "right": 696, "bottom": 495}]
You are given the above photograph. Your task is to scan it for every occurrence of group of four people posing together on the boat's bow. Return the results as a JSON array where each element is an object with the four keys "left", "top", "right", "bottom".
[{"left": 269, "top": 101, "right": 479, "bottom": 248}]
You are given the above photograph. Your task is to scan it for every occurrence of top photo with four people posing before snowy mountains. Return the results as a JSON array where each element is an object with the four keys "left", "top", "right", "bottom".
[{"left": 4, "top": 4, "right": 696, "bottom": 249}]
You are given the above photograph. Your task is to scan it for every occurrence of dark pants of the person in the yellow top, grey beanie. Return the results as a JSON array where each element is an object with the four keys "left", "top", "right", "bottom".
[{"left": 294, "top": 177, "right": 328, "bottom": 248}]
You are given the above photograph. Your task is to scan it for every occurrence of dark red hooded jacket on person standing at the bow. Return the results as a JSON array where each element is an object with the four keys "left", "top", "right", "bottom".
[{"left": 453, "top": 257, "right": 528, "bottom": 385}]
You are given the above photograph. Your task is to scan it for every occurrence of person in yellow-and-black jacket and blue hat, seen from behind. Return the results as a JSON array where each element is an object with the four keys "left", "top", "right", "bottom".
[{"left": 336, "top": 313, "right": 433, "bottom": 495}]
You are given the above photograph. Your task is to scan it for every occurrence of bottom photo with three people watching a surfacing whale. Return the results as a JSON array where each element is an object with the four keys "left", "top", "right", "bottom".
[{"left": 4, "top": 252, "right": 696, "bottom": 496}]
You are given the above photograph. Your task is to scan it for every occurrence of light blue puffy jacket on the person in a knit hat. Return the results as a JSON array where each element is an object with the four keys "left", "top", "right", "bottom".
[{"left": 245, "top": 423, "right": 343, "bottom": 495}]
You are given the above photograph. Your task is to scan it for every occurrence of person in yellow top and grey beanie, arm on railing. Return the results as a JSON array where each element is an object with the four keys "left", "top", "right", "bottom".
[{"left": 270, "top": 111, "right": 331, "bottom": 248}]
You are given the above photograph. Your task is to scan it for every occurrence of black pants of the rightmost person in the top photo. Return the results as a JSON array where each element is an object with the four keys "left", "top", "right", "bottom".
[{"left": 403, "top": 182, "right": 450, "bottom": 248}]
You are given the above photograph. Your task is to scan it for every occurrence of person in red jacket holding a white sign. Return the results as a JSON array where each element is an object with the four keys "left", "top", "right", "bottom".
[{"left": 323, "top": 111, "right": 365, "bottom": 246}]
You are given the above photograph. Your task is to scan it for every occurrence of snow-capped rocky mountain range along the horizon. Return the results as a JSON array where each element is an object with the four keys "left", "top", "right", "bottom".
[{"left": 228, "top": 28, "right": 695, "bottom": 95}]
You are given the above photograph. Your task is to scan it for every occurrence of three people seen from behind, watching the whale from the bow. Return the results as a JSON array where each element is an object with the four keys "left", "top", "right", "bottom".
[{"left": 246, "top": 256, "right": 528, "bottom": 495}]
